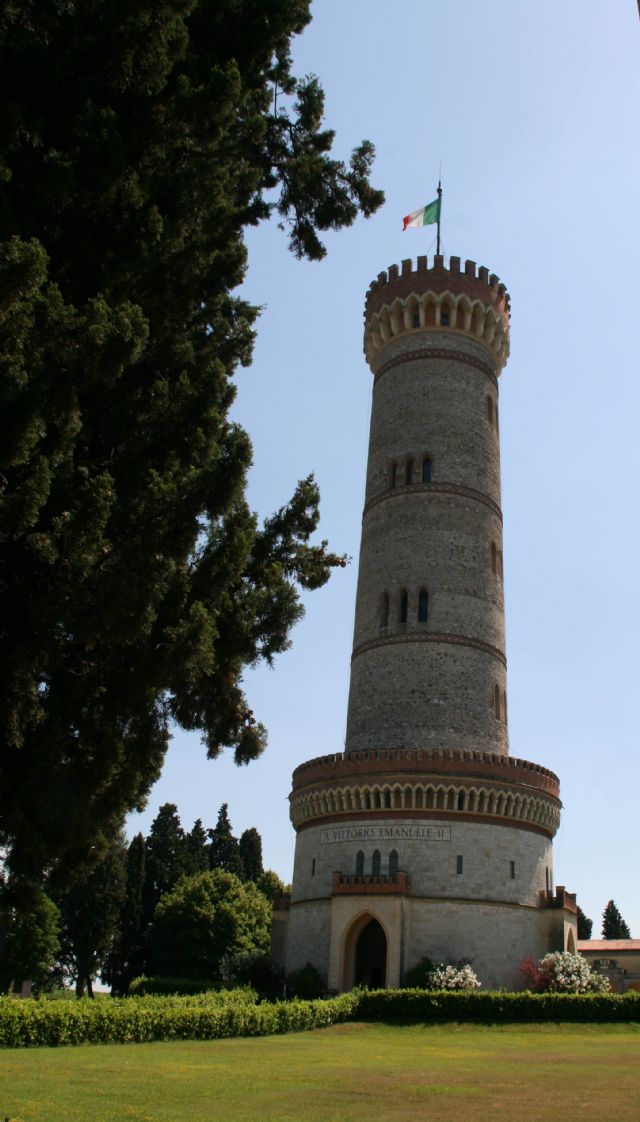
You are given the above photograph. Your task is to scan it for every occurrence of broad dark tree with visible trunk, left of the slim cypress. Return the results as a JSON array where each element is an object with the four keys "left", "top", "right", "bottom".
[{"left": 57, "top": 834, "right": 127, "bottom": 997}]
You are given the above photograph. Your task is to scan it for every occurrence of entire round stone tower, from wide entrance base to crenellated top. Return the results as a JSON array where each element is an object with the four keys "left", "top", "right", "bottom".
[{"left": 276, "top": 256, "right": 576, "bottom": 990}]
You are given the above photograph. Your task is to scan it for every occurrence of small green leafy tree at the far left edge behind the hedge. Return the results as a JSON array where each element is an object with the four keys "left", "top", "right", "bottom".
[{"left": 0, "top": 891, "right": 60, "bottom": 991}]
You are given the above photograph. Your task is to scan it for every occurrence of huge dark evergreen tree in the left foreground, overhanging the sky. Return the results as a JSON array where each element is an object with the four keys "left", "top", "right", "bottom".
[{"left": 0, "top": 0, "right": 383, "bottom": 885}]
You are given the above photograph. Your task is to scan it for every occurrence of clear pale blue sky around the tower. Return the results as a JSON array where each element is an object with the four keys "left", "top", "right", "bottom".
[{"left": 129, "top": 0, "right": 640, "bottom": 937}]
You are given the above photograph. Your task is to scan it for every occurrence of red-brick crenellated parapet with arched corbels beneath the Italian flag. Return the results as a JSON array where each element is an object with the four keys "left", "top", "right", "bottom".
[{"left": 364, "top": 255, "right": 511, "bottom": 374}]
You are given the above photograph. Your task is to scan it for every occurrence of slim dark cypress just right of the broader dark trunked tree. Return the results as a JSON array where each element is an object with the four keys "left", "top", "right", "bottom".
[{"left": 102, "top": 834, "right": 146, "bottom": 994}]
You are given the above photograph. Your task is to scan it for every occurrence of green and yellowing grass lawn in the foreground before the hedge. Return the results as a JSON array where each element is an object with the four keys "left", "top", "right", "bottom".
[{"left": 0, "top": 1023, "right": 640, "bottom": 1122}]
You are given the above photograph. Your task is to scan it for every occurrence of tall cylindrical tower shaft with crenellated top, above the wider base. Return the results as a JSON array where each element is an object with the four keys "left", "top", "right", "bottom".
[{"left": 346, "top": 257, "right": 509, "bottom": 754}]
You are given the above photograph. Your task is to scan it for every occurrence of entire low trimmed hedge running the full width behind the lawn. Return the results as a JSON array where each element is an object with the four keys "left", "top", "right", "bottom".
[{"left": 0, "top": 990, "right": 640, "bottom": 1048}]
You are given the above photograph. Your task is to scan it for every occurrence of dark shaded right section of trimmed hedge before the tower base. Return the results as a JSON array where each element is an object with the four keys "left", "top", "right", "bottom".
[{"left": 355, "top": 990, "right": 640, "bottom": 1024}]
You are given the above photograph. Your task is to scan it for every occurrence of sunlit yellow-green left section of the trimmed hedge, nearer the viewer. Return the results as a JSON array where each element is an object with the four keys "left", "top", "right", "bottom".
[{"left": 0, "top": 993, "right": 357, "bottom": 1048}]
